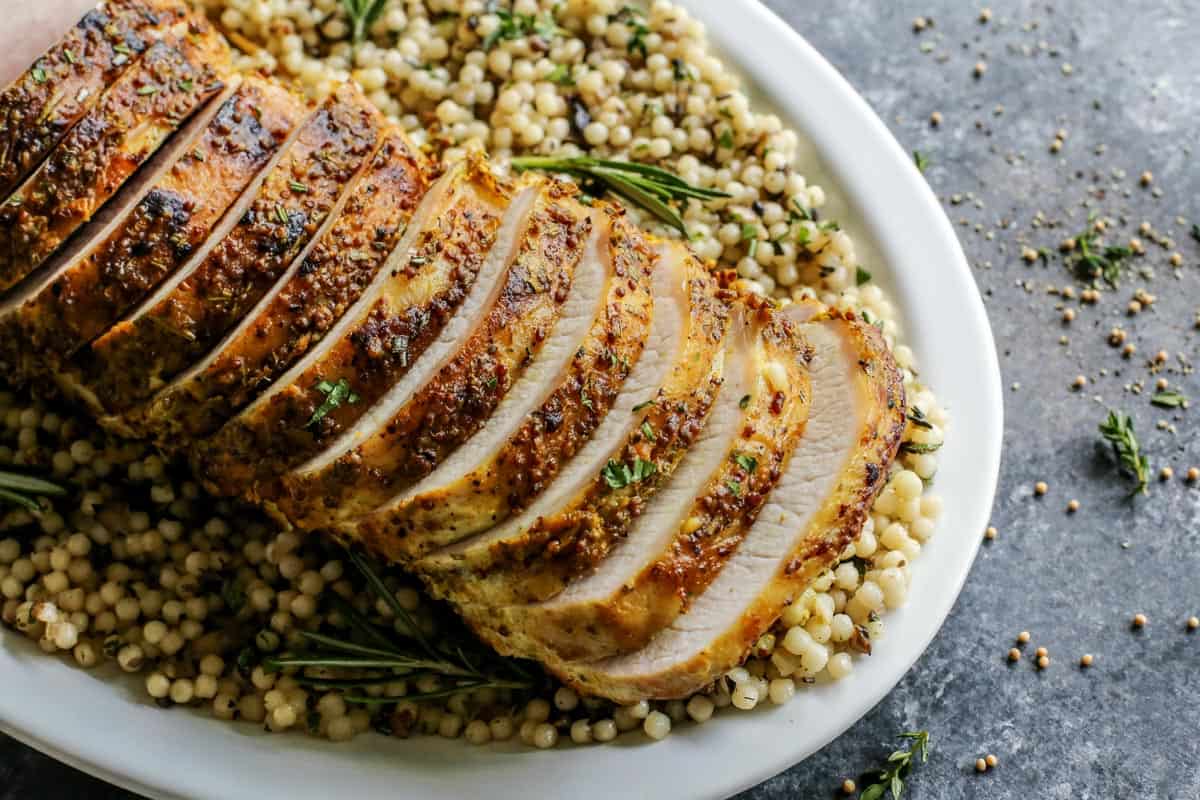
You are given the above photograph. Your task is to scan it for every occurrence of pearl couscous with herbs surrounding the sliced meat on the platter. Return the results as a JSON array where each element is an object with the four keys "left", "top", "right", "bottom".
[{"left": 0, "top": 0, "right": 950, "bottom": 748}]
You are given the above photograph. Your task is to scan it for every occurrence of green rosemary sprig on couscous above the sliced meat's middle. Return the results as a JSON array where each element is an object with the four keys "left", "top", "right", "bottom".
[{"left": 512, "top": 156, "right": 730, "bottom": 236}]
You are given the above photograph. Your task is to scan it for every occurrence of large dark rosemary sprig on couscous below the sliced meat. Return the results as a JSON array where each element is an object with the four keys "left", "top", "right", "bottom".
[{"left": 263, "top": 551, "right": 535, "bottom": 705}]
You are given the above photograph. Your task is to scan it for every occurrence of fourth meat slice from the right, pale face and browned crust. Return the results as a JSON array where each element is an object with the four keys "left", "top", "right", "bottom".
[{"left": 342, "top": 204, "right": 654, "bottom": 560}]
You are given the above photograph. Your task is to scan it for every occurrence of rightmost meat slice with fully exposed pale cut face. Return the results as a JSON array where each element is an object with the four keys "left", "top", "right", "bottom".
[{"left": 551, "top": 307, "right": 906, "bottom": 702}]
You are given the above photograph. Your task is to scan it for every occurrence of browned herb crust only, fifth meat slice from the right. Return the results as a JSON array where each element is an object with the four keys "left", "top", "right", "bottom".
[{"left": 277, "top": 182, "right": 592, "bottom": 529}]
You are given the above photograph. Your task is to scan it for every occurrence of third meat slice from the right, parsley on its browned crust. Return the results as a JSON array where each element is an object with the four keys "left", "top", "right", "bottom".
[{"left": 417, "top": 246, "right": 730, "bottom": 606}]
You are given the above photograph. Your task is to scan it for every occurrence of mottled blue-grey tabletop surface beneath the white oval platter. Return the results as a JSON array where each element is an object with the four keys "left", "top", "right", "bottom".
[{"left": 0, "top": 0, "right": 1200, "bottom": 800}]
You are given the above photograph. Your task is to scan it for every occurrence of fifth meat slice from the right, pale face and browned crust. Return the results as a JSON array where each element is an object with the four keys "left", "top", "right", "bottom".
[{"left": 275, "top": 179, "right": 599, "bottom": 529}]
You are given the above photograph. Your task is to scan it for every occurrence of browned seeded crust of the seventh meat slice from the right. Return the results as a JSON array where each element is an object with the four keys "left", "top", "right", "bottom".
[{"left": 131, "top": 130, "right": 428, "bottom": 443}]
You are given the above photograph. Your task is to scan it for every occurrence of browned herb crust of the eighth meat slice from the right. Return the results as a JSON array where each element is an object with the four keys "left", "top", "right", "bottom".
[{"left": 80, "top": 84, "right": 382, "bottom": 414}]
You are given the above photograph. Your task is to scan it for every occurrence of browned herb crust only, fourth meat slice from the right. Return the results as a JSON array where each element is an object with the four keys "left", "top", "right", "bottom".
[{"left": 347, "top": 205, "right": 654, "bottom": 561}]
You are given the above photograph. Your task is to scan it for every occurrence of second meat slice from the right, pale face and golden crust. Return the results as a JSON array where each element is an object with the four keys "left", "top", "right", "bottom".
[{"left": 488, "top": 299, "right": 810, "bottom": 661}]
